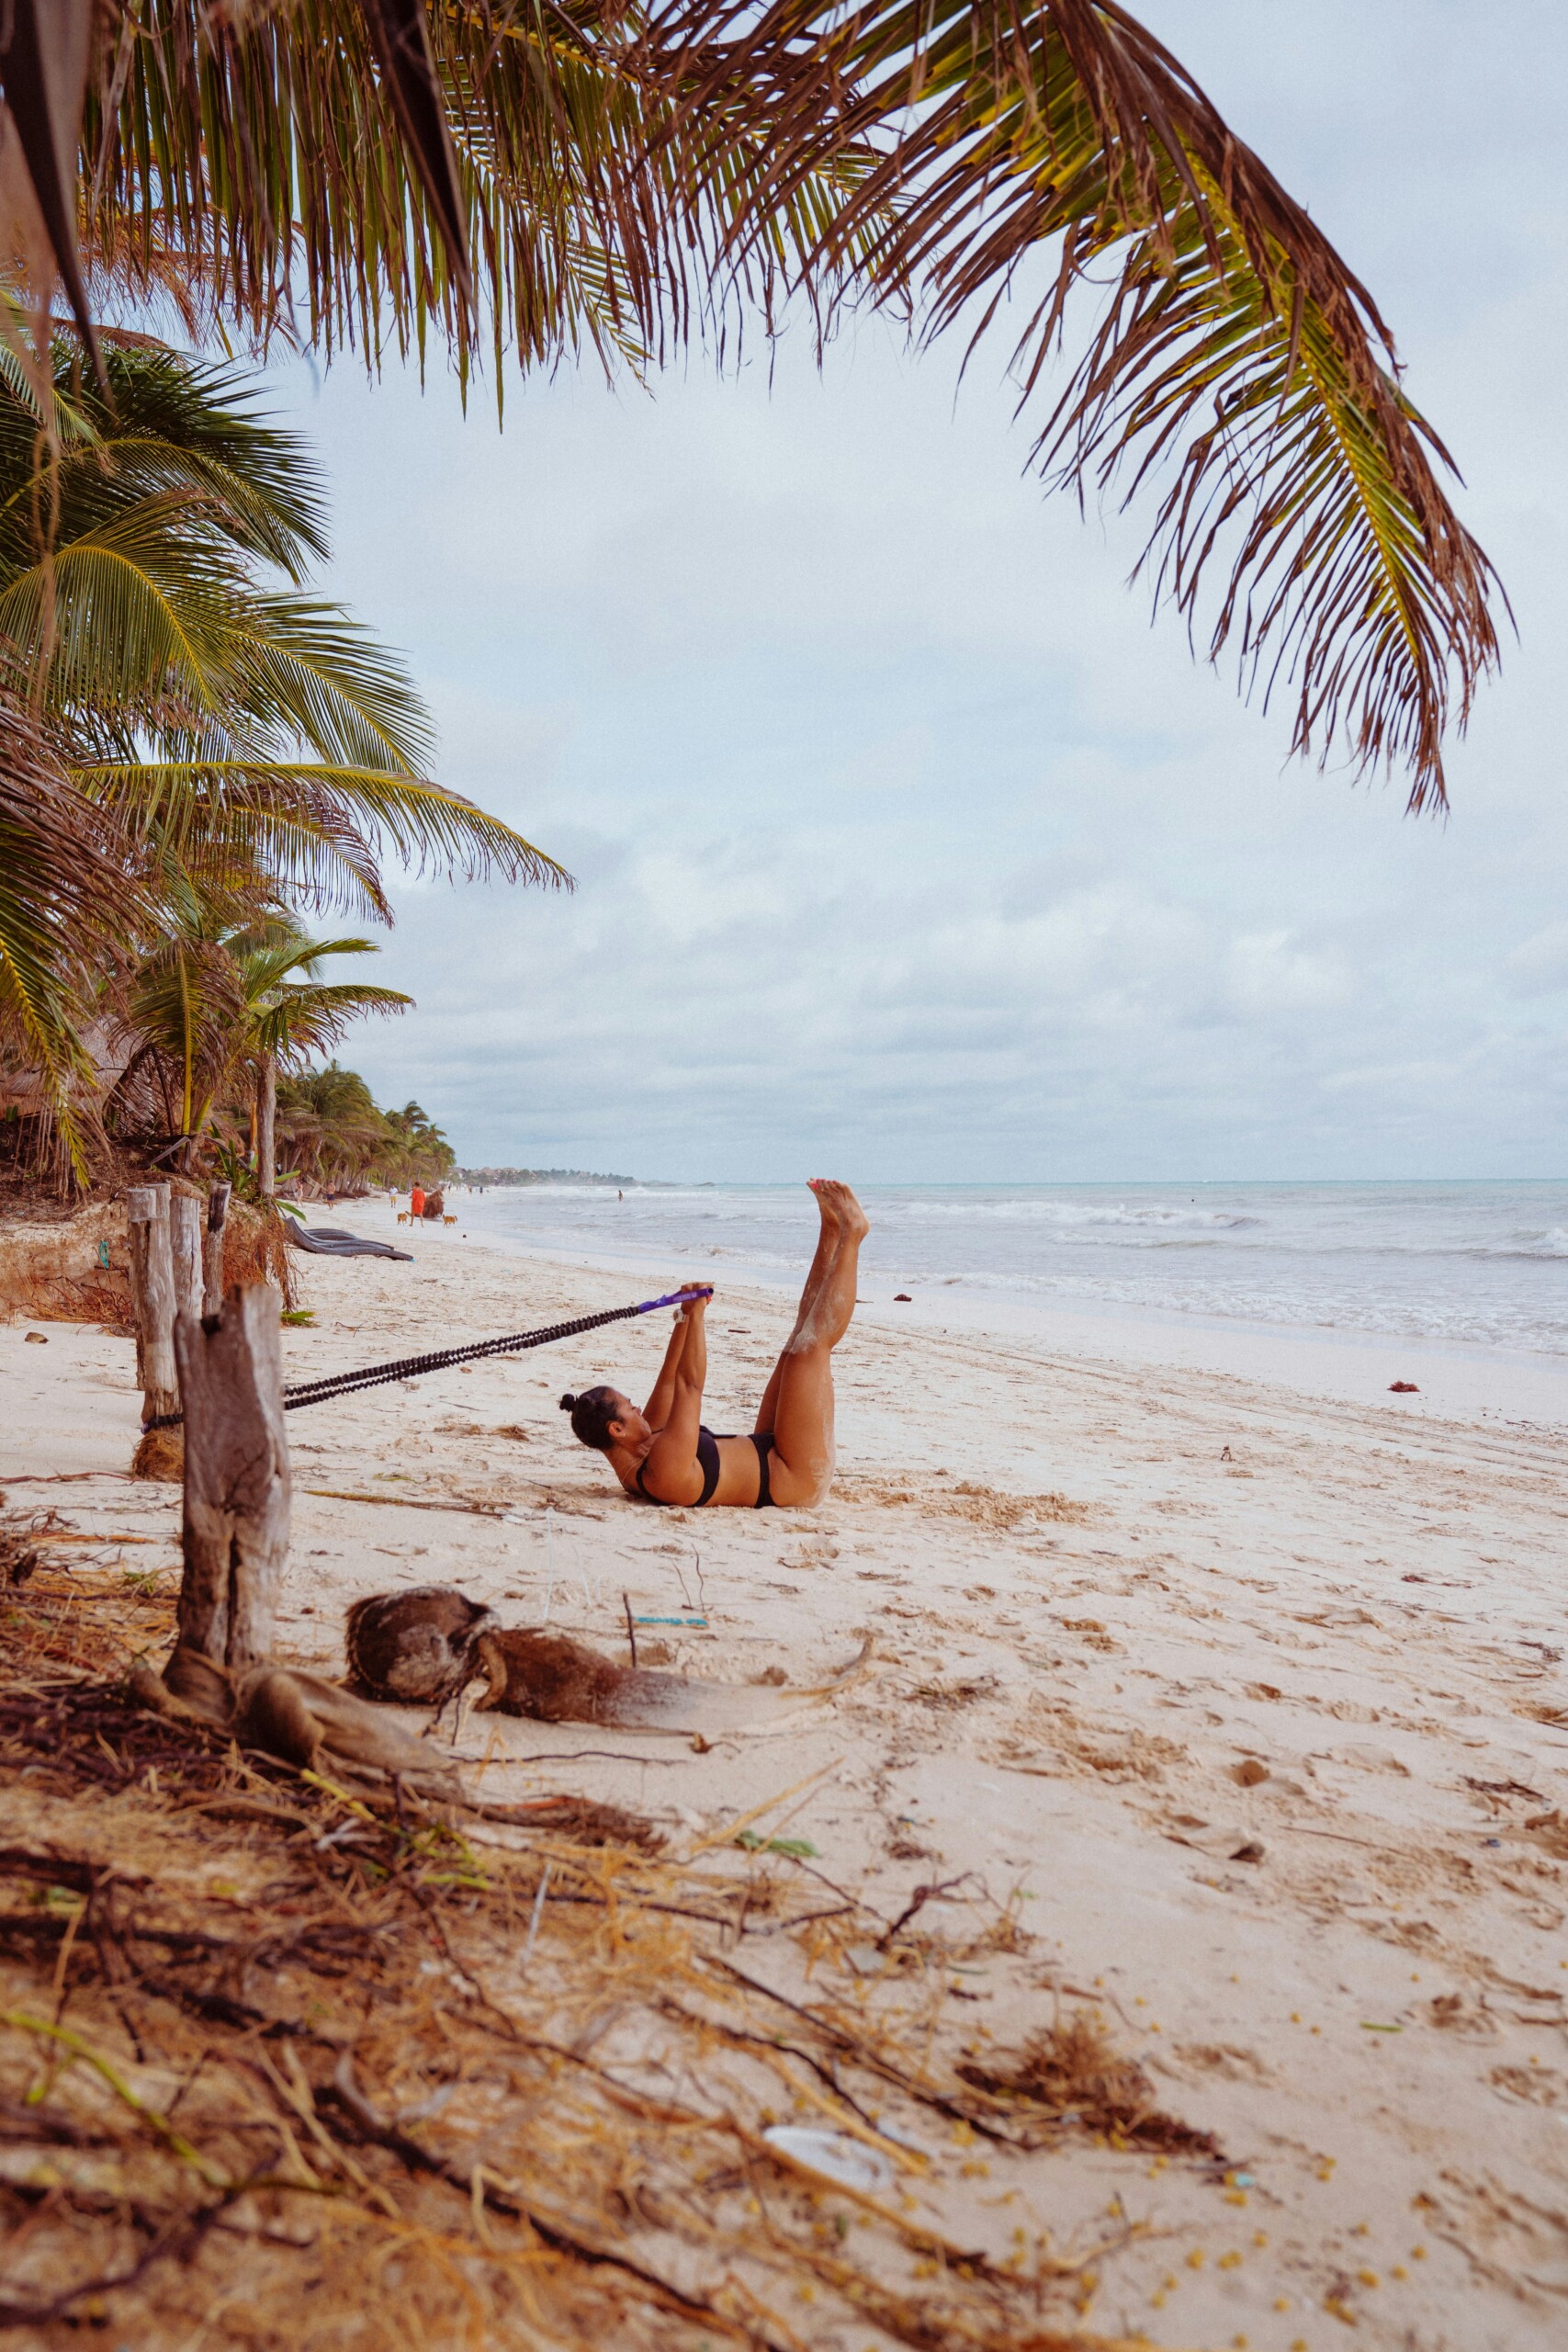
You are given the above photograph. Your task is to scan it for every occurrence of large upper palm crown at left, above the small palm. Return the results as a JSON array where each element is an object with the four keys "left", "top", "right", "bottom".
[{"left": 0, "top": 344, "right": 564, "bottom": 920}]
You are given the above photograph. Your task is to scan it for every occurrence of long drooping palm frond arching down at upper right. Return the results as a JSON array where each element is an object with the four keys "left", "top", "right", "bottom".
[{"left": 647, "top": 0, "right": 1497, "bottom": 809}]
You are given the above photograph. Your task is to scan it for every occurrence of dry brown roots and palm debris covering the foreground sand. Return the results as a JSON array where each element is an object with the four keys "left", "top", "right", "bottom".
[{"left": 0, "top": 1536, "right": 1189, "bottom": 2352}]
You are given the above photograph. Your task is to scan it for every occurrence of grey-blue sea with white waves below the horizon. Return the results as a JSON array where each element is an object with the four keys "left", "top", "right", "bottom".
[{"left": 446, "top": 1181, "right": 1568, "bottom": 1357}]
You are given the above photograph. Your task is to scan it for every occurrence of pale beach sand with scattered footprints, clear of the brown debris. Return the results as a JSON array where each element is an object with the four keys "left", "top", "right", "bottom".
[{"left": 0, "top": 1206, "right": 1568, "bottom": 2352}]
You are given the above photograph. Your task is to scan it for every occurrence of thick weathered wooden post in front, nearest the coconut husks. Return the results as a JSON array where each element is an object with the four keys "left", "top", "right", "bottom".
[{"left": 174, "top": 1282, "right": 291, "bottom": 1670}]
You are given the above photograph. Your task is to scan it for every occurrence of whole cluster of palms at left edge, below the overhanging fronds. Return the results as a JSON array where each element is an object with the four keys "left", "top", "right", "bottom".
[{"left": 0, "top": 339, "right": 567, "bottom": 1193}]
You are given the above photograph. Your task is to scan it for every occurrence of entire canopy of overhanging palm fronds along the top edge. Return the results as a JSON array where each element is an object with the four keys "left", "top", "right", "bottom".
[{"left": 5, "top": 0, "right": 1497, "bottom": 807}]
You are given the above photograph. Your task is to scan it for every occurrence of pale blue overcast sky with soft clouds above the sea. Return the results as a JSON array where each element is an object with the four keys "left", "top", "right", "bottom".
[{"left": 273, "top": 0, "right": 1568, "bottom": 1181}]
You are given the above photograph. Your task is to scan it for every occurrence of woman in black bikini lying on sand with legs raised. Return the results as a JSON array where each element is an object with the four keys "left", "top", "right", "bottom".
[{"left": 562, "top": 1176, "right": 867, "bottom": 1510}]
